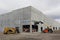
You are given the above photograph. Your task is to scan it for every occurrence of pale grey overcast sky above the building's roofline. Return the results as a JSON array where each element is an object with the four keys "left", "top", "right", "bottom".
[{"left": 0, "top": 0, "right": 60, "bottom": 22}]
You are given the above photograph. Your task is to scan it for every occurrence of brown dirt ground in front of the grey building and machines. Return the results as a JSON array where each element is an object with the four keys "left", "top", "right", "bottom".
[{"left": 0, "top": 33, "right": 60, "bottom": 40}]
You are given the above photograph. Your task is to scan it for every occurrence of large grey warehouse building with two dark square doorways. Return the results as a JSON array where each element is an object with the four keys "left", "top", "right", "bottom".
[{"left": 0, "top": 6, "right": 60, "bottom": 32}]
